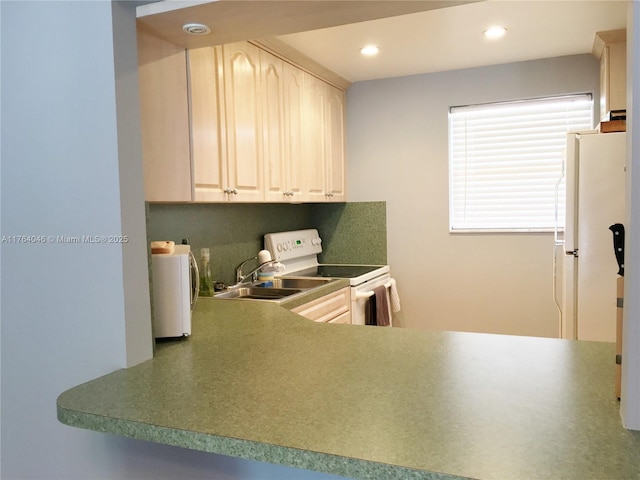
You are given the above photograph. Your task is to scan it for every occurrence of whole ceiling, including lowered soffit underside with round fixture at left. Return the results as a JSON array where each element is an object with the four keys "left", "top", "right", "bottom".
[{"left": 138, "top": 0, "right": 629, "bottom": 82}]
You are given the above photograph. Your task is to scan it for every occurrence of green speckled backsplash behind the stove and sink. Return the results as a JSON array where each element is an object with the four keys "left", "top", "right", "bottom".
[{"left": 147, "top": 202, "right": 387, "bottom": 284}]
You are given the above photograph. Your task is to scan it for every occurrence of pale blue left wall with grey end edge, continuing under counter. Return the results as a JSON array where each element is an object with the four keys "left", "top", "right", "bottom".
[{"left": 0, "top": 1, "right": 344, "bottom": 480}]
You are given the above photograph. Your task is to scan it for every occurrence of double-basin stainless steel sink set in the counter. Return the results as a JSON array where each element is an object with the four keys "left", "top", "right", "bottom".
[{"left": 215, "top": 278, "right": 335, "bottom": 301}]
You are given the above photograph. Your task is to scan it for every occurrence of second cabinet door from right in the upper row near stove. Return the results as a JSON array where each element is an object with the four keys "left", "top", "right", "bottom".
[{"left": 303, "top": 73, "right": 327, "bottom": 202}]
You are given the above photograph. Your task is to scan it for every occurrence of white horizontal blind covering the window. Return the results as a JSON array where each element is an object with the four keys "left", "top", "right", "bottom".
[{"left": 449, "top": 94, "right": 593, "bottom": 232}]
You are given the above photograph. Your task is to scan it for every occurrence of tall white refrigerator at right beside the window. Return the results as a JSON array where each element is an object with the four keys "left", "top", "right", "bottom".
[{"left": 554, "top": 132, "right": 626, "bottom": 342}]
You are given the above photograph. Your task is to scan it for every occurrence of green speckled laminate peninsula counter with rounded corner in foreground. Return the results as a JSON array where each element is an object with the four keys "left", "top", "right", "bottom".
[{"left": 58, "top": 299, "right": 640, "bottom": 480}]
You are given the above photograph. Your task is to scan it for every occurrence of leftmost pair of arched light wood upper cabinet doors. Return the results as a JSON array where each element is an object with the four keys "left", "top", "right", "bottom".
[{"left": 188, "top": 43, "right": 264, "bottom": 202}]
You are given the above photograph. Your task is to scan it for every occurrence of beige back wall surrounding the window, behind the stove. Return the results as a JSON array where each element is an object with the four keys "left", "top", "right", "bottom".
[{"left": 347, "top": 55, "right": 599, "bottom": 337}]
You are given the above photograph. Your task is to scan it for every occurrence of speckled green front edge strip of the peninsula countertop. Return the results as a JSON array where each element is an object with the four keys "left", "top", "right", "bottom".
[{"left": 57, "top": 404, "right": 473, "bottom": 480}]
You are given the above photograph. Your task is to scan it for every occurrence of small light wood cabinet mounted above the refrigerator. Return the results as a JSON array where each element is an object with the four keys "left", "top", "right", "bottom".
[{"left": 592, "top": 29, "right": 627, "bottom": 121}]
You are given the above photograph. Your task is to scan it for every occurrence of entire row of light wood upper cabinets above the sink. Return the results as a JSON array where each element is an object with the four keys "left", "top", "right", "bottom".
[{"left": 139, "top": 32, "right": 345, "bottom": 203}]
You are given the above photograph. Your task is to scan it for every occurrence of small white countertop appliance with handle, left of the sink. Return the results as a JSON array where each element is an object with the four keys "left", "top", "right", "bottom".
[{"left": 151, "top": 245, "right": 199, "bottom": 338}]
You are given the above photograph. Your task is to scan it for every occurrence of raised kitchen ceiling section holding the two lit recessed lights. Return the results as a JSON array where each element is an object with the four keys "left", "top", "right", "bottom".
[{"left": 278, "top": 0, "right": 628, "bottom": 82}]
